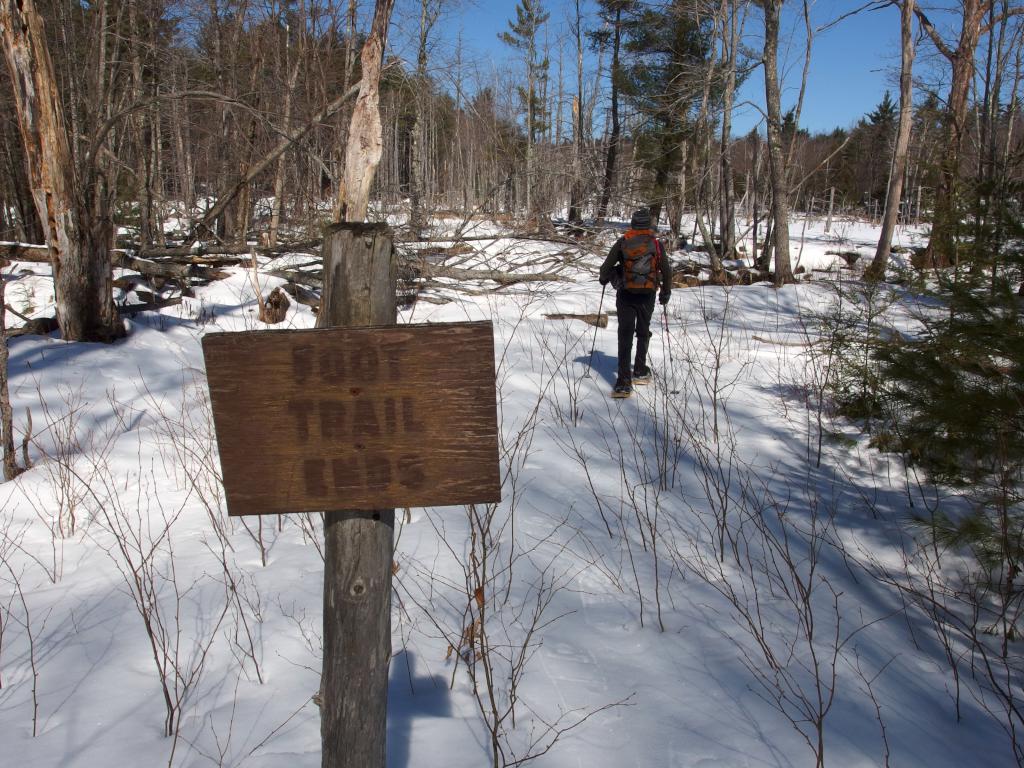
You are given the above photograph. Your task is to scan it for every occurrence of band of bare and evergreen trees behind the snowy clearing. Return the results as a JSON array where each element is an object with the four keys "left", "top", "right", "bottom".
[{"left": 0, "top": 0, "right": 1024, "bottom": 337}]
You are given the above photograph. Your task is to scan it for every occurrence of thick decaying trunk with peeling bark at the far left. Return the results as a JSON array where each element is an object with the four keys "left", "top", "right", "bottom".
[{"left": 0, "top": 0, "right": 124, "bottom": 341}]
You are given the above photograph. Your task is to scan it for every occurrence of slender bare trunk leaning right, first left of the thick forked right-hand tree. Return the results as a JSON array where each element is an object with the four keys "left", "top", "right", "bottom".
[{"left": 868, "top": 0, "right": 914, "bottom": 281}]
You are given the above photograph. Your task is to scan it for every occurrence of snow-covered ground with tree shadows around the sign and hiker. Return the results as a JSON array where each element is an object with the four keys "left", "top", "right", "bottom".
[{"left": 0, "top": 214, "right": 1015, "bottom": 768}]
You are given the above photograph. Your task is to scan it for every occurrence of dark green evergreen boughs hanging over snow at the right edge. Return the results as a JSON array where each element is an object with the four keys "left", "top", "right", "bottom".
[{"left": 864, "top": 198, "right": 1024, "bottom": 639}]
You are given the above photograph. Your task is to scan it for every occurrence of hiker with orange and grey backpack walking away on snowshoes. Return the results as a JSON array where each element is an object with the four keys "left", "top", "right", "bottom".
[{"left": 601, "top": 208, "right": 672, "bottom": 397}]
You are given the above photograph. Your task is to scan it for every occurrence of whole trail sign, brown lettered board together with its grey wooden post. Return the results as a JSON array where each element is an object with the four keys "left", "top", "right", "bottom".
[{"left": 203, "top": 223, "right": 501, "bottom": 768}]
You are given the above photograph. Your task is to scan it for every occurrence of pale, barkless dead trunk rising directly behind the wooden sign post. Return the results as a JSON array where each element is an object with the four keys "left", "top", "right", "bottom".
[{"left": 338, "top": 0, "right": 394, "bottom": 221}]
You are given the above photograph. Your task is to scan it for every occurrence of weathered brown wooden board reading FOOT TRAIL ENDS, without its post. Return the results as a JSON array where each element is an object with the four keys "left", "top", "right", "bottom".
[{"left": 203, "top": 323, "right": 501, "bottom": 515}]
